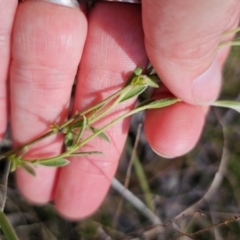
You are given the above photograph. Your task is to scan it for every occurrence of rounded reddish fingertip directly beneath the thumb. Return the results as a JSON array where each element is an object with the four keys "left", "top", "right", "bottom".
[{"left": 144, "top": 86, "right": 208, "bottom": 158}]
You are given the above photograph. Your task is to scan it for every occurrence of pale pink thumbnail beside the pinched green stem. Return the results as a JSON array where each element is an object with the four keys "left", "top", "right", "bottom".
[{"left": 192, "top": 60, "right": 221, "bottom": 105}]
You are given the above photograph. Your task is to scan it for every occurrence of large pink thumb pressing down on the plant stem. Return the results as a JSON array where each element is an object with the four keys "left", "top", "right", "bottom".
[{"left": 142, "top": 0, "right": 240, "bottom": 105}]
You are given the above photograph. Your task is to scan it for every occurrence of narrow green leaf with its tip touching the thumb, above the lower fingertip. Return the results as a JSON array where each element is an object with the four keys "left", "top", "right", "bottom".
[{"left": 137, "top": 98, "right": 180, "bottom": 109}]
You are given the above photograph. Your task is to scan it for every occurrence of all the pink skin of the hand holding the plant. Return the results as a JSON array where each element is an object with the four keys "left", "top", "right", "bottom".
[{"left": 0, "top": 0, "right": 239, "bottom": 219}]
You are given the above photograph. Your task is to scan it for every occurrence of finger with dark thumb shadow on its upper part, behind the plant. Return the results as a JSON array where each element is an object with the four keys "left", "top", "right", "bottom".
[{"left": 55, "top": 3, "right": 147, "bottom": 219}]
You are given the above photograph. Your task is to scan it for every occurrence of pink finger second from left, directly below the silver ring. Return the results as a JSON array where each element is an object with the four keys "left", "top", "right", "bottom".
[{"left": 11, "top": 1, "right": 87, "bottom": 203}]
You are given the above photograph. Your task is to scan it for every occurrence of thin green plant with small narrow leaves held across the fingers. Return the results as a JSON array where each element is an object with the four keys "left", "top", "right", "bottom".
[{"left": 0, "top": 28, "right": 240, "bottom": 240}]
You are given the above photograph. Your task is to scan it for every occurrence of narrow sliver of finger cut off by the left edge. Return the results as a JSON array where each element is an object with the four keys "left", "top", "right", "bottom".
[{"left": 0, "top": 0, "right": 18, "bottom": 140}]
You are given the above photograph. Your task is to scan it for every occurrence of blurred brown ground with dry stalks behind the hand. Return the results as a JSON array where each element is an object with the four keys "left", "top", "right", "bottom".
[{"left": 0, "top": 44, "right": 240, "bottom": 240}]
